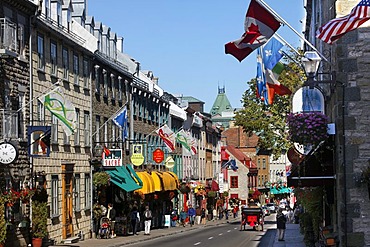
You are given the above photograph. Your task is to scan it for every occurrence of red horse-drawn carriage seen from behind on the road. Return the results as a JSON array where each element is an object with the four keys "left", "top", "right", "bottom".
[{"left": 240, "top": 207, "right": 264, "bottom": 231}]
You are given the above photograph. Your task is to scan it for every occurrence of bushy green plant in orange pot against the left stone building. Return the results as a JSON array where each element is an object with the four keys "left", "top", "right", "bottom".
[{"left": 32, "top": 201, "right": 48, "bottom": 238}]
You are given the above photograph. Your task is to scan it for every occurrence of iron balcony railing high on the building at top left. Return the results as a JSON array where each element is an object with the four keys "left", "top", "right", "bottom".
[{"left": 0, "top": 18, "right": 17, "bottom": 52}]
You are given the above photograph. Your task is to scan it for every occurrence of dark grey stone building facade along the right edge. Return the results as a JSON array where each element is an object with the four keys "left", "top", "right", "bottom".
[{"left": 306, "top": 0, "right": 370, "bottom": 246}]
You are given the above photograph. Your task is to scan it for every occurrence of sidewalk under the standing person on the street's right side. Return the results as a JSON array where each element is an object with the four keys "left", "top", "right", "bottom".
[{"left": 272, "top": 224, "right": 306, "bottom": 247}]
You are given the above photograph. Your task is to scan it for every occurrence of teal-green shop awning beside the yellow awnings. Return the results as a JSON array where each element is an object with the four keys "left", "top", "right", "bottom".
[{"left": 106, "top": 166, "right": 142, "bottom": 192}]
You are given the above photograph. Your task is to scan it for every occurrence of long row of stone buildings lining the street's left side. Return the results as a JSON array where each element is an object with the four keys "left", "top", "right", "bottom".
[{"left": 0, "top": 0, "right": 286, "bottom": 246}]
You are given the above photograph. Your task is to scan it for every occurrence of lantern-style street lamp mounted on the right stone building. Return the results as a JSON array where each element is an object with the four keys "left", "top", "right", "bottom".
[{"left": 301, "top": 51, "right": 321, "bottom": 89}]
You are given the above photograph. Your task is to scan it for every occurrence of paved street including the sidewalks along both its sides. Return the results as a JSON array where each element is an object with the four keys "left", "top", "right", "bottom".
[{"left": 53, "top": 214, "right": 305, "bottom": 247}]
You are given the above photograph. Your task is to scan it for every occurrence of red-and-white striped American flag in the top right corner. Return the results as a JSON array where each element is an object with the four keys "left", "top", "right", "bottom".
[{"left": 316, "top": 0, "right": 370, "bottom": 44}]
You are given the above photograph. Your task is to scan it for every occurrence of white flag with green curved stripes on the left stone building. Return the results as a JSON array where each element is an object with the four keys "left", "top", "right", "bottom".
[{"left": 38, "top": 87, "right": 77, "bottom": 136}]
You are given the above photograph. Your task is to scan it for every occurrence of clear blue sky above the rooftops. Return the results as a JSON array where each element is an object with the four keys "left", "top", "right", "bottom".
[{"left": 87, "top": 0, "right": 304, "bottom": 112}]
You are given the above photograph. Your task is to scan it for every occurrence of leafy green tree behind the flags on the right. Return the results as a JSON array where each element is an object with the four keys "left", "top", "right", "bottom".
[{"left": 235, "top": 53, "right": 304, "bottom": 158}]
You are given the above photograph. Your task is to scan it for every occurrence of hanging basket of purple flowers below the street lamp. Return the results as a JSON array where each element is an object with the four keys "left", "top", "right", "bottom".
[{"left": 287, "top": 112, "right": 329, "bottom": 146}]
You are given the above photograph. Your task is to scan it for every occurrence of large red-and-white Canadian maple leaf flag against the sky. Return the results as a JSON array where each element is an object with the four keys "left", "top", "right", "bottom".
[{"left": 225, "top": 0, "right": 281, "bottom": 62}]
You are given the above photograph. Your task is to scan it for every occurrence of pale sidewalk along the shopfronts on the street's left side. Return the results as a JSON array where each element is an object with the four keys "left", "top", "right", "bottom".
[{"left": 54, "top": 217, "right": 240, "bottom": 247}]
